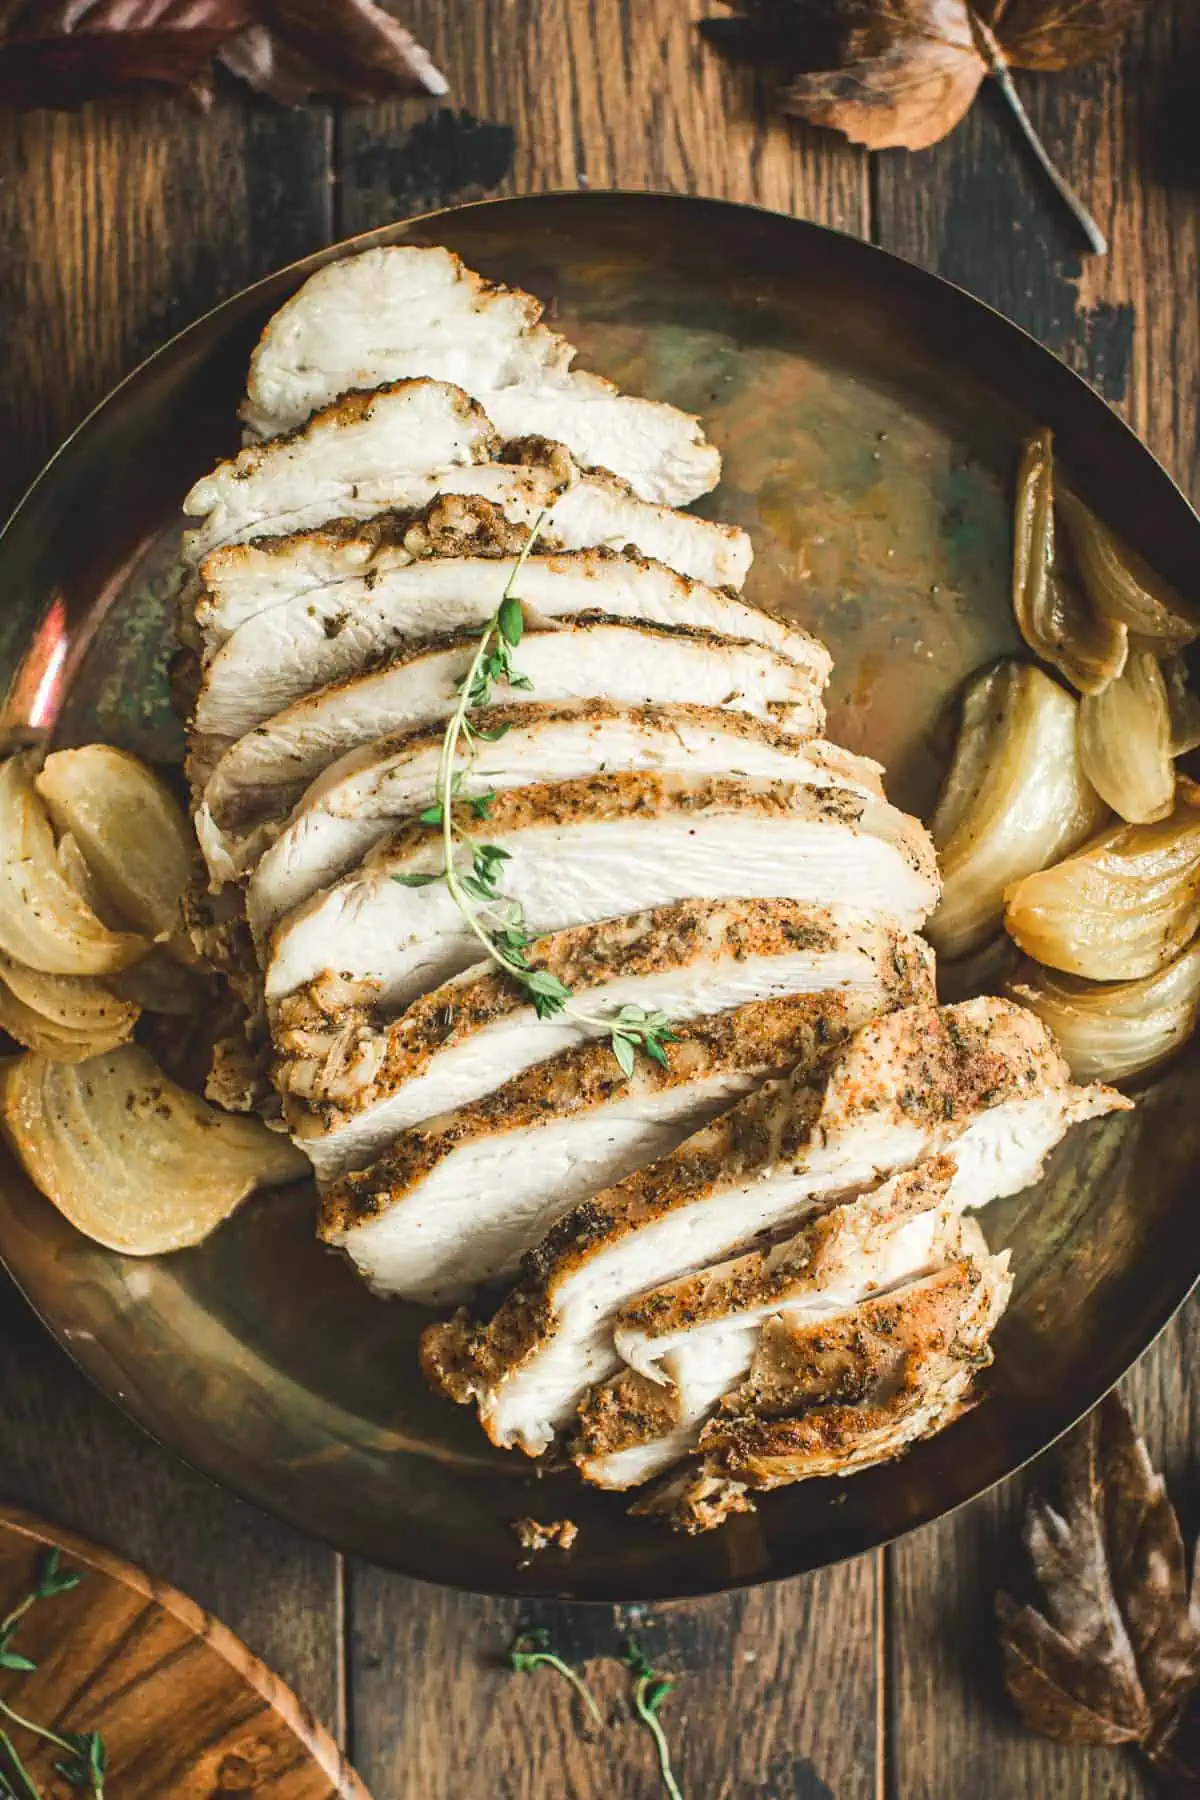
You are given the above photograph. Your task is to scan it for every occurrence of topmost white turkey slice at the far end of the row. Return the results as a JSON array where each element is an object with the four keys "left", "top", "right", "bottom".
[{"left": 243, "top": 245, "right": 721, "bottom": 506}]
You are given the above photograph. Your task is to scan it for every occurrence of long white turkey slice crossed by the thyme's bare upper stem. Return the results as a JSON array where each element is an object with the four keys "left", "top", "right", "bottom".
[{"left": 193, "top": 540, "right": 829, "bottom": 767}]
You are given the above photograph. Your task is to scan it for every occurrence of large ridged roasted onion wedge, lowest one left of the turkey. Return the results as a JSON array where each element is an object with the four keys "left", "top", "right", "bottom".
[{"left": 0, "top": 1044, "right": 308, "bottom": 1256}]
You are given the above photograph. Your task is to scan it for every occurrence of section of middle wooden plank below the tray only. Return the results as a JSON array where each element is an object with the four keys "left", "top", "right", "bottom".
[{"left": 349, "top": 1552, "right": 876, "bottom": 1800}]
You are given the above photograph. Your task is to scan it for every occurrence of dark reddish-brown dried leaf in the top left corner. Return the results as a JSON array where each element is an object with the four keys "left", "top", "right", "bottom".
[{"left": 0, "top": 0, "right": 446, "bottom": 108}]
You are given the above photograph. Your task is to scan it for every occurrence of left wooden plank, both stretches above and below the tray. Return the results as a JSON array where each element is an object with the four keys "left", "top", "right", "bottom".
[{"left": 0, "top": 95, "right": 342, "bottom": 1726}]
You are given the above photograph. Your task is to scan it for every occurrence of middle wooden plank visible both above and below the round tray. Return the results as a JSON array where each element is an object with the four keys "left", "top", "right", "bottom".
[{"left": 338, "top": 0, "right": 876, "bottom": 1800}]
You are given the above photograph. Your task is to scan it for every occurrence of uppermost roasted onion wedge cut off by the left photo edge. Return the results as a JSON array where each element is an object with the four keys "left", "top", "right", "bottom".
[{"left": 0, "top": 756, "right": 148, "bottom": 976}]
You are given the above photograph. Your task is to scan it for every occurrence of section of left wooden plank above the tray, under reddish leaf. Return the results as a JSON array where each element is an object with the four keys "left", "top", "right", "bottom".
[{"left": 0, "top": 94, "right": 333, "bottom": 513}]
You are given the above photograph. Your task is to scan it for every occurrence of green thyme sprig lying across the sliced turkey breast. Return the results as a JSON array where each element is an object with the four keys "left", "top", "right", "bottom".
[{"left": 392, "top": 509, "right": 676, "bottom": 1076}]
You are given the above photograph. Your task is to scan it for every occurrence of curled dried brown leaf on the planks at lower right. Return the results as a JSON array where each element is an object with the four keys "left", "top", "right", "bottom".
[{"left": 997, "top": 1395, "right": 1200, "bottom": 1771}]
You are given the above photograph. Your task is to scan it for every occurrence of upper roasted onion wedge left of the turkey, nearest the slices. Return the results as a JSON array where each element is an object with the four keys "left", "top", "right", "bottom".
[{"left": 36, "top": 743, "right": 196, "bottom": 940}]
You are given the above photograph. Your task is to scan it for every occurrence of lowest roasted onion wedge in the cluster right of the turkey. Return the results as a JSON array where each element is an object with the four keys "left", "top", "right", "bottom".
[{"left": 1006, "top": 943, "right": 1200, "bottom": 1082}]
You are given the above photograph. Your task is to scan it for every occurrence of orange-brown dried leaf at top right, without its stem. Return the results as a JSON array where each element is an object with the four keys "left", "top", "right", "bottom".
[{"left": 707, "top": 0, "right": 1146, "bottom": 149}]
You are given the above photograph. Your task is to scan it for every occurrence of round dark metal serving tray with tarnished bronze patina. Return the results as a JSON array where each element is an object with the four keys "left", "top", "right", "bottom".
[{"left": 0, "top": 194, "right": 1200, "bottom": 1600}]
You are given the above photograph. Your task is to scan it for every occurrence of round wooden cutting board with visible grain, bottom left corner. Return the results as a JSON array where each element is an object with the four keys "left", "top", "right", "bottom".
[{"left": 0, "top": 1507, "right": 371, "bottom": 1800}]
